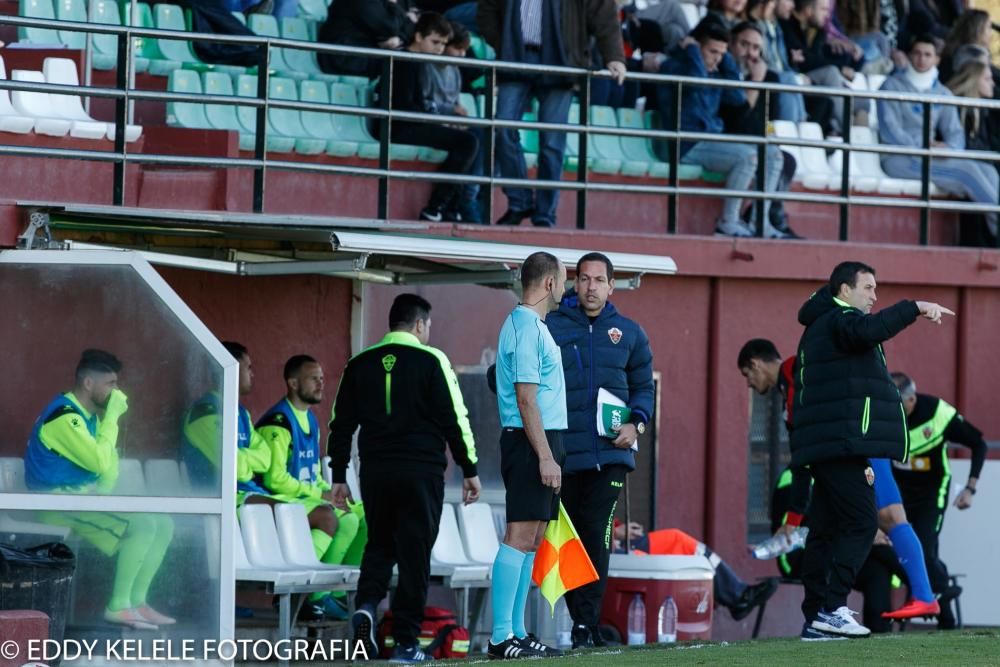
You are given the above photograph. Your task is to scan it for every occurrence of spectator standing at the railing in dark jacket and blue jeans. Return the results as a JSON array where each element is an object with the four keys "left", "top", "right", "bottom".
[{"left": 478, "top": 0, "right": 625, "bottom": 227}]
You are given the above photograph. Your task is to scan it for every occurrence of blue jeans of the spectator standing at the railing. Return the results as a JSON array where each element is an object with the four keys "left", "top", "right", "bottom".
[{"left": 496, "top": 51, "right": 583, "bottom": 226}]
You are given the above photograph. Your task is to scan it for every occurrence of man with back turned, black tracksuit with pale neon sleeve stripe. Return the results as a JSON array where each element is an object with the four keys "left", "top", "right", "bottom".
[{"left": 328, "top": 294, "right": 481, "bottom": 662}]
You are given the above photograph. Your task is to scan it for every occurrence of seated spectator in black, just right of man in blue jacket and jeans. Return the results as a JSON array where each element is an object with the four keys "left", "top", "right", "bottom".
[{"left": 720, "top": 21, "right": 801, "bottom": 238}]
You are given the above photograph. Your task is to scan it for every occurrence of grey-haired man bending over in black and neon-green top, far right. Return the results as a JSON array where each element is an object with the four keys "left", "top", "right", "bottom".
[{"left": 892, "top": 373, "right": 986, "bottom": 630}]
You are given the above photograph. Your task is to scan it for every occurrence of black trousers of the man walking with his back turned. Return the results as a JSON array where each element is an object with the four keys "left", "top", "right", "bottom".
[{"left": 357, "top": 465, "right": 444, "bottom": 646}]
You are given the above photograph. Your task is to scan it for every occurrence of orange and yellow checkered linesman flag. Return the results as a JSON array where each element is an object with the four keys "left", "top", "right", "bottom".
[{"left": 531, "top": 501, "right": 598, "bottom": 615}]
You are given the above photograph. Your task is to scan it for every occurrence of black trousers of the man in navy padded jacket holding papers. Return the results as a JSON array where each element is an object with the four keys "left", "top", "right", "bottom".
[{"left": 561, "top": 465, "right": 628, "bottom": 626}]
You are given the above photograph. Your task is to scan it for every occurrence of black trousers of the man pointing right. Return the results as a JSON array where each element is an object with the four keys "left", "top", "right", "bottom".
[{"left": 802, "top": 458, "right": 878, "bottom": 623}]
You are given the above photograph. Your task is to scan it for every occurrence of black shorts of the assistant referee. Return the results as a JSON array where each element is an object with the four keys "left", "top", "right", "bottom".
[{"left": 500, "top": 428, "right": 566, "bottom": 523}]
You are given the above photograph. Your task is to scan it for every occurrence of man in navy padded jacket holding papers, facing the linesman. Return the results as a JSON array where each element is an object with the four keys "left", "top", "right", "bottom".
[{"left": 545, "top": 252, "right": 653, "bottom": 648}]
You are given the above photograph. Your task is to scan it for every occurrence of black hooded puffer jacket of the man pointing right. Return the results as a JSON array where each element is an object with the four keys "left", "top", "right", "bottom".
[{"left": 791, "top": 287, "right": 920, "bottom": 466}]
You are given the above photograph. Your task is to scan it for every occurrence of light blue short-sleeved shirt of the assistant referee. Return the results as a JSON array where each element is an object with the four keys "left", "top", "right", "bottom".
[{"left": 497, "top": 306, "right": 566, "bottom": 431}]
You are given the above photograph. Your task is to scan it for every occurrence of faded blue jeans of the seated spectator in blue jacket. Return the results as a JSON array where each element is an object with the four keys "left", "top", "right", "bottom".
[{"left": 681, "top": 141, "right": 785, "bottom": 225}]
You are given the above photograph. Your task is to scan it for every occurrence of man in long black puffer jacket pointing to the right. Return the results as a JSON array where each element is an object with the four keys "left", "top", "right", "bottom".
[{"left": 791, "top": 262, "right": 954, "bottom": 640}]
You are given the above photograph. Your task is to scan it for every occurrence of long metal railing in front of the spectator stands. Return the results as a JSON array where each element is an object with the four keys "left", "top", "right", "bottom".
[{"left": 0, "top": 16, "right": 1000, "bottom": 245}]
